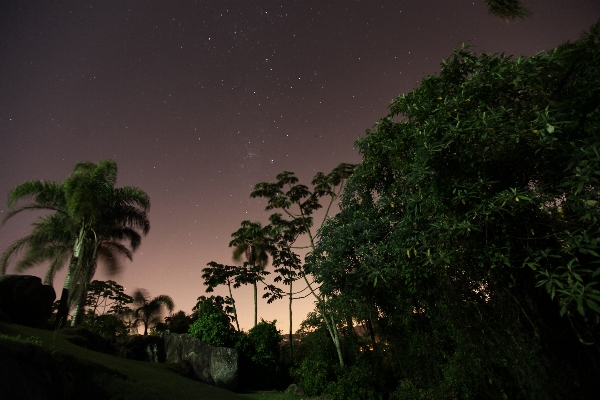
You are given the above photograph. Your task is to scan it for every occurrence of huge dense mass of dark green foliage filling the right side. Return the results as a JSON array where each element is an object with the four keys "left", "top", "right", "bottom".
[{"left": 308, "top": 23, "right": 600, "bottom": 399}]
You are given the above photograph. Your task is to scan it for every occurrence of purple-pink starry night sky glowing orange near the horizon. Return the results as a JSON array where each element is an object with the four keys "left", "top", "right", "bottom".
[{"left": 0, "top": 0, "right": 600, "bottom": 332}]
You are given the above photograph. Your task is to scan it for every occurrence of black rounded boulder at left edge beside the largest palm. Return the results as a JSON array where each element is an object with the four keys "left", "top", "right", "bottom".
[{"left": 0, "top": 275, "right": 56, "bottom": 328}]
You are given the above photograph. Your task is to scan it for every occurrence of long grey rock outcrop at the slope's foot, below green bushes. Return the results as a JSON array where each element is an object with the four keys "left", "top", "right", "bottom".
[{"left": 161, "top": 331, "right": 238, "bottom": 390}]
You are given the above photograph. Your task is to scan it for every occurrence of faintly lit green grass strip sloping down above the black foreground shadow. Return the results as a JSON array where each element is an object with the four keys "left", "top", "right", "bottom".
[{"left": 0, "top": 323, "right": 248, "bottom": 400}]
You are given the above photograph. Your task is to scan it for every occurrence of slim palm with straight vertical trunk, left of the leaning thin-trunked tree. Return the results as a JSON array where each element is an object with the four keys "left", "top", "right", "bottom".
[{"left": 229, "top": 221, "right": 275, "bottom": 326}]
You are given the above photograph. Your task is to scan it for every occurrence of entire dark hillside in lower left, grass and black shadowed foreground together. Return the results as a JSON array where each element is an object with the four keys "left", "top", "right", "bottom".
[{"left": 0, "top": 323, "right": 246, "bottom": 400}]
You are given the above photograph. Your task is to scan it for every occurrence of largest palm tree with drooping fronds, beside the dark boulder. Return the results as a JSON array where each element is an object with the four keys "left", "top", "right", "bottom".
[{"left": 0, "top": 159, "right": 150, "bottom": 326}]
